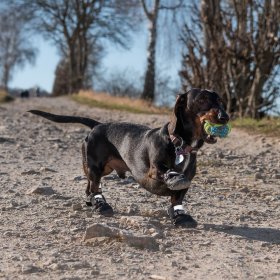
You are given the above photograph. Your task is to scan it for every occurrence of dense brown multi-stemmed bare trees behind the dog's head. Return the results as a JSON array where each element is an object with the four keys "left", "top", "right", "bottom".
[{"left": 180, "top": 0, "right": 280, "bottom": 118}]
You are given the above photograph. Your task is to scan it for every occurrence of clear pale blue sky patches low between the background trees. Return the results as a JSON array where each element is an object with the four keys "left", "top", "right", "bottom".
[{"left": 9, "top": 32, "right": 180, "bottom": 92}]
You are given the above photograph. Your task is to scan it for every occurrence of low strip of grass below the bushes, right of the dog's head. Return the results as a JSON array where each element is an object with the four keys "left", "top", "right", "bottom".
[{"left": 232, "top": 117, "right": 280, "bottom": 136}]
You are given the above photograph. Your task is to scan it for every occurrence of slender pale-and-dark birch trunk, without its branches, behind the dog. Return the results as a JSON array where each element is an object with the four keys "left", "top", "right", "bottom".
[{"left": 141, "top": 0, "right": 160, "bottom": 101}]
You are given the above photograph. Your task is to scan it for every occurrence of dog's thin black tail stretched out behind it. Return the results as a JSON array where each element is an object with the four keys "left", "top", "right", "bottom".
[{"left": 28, "top": 110, "right": 100, "bottom": 128}]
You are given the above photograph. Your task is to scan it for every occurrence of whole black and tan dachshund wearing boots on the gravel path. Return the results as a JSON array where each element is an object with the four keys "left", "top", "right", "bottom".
[{"left": 29, "top": 88, "right": 229, "bottom": 227}]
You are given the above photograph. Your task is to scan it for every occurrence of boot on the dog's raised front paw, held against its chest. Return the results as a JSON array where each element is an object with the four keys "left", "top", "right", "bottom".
[{"left": 163, "top": 170, "right": 191, "bottom": 190}]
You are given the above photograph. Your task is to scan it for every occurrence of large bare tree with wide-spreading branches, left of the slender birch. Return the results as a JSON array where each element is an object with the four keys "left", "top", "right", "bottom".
[{"left": 14, "top": 0, "right": 140, "bottom": 93}]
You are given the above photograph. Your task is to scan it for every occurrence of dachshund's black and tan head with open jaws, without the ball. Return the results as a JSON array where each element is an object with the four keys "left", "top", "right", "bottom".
[{"left": 169, "top": 88, "right": 229, "bottom": 144}]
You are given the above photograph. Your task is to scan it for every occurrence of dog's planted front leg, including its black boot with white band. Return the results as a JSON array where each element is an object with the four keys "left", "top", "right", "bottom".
[{"left": 167, "top": 189, "right": 197, "bottom": 227}]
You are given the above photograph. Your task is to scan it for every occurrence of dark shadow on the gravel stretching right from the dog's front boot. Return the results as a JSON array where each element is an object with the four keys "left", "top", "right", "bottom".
[{"left": 204, "top": 224, "right": 280, "bottom": 244}]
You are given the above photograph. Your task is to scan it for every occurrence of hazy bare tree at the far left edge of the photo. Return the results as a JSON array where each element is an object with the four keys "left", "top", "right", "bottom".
[{"left": 0, "top": 7, "right": 36, "bottom": 89}]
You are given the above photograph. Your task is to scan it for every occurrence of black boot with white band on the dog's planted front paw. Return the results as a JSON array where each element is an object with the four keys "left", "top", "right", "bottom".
[{"left": 167, "top": 205, "right": 197, "bottom": 228}]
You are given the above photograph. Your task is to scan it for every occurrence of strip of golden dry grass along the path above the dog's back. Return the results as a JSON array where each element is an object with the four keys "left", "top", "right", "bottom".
[{"left": 71, "top": 91, "right": 170, "bottom": 114}]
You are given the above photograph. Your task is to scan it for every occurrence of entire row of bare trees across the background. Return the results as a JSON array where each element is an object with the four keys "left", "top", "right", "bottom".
[{"left": 0, "top": 0, "right": 280, "bottom": 118}]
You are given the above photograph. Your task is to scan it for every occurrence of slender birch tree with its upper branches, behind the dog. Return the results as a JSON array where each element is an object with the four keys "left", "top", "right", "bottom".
[{"left": 141, "top": 0, "right": 183, "bottom": 101}]
